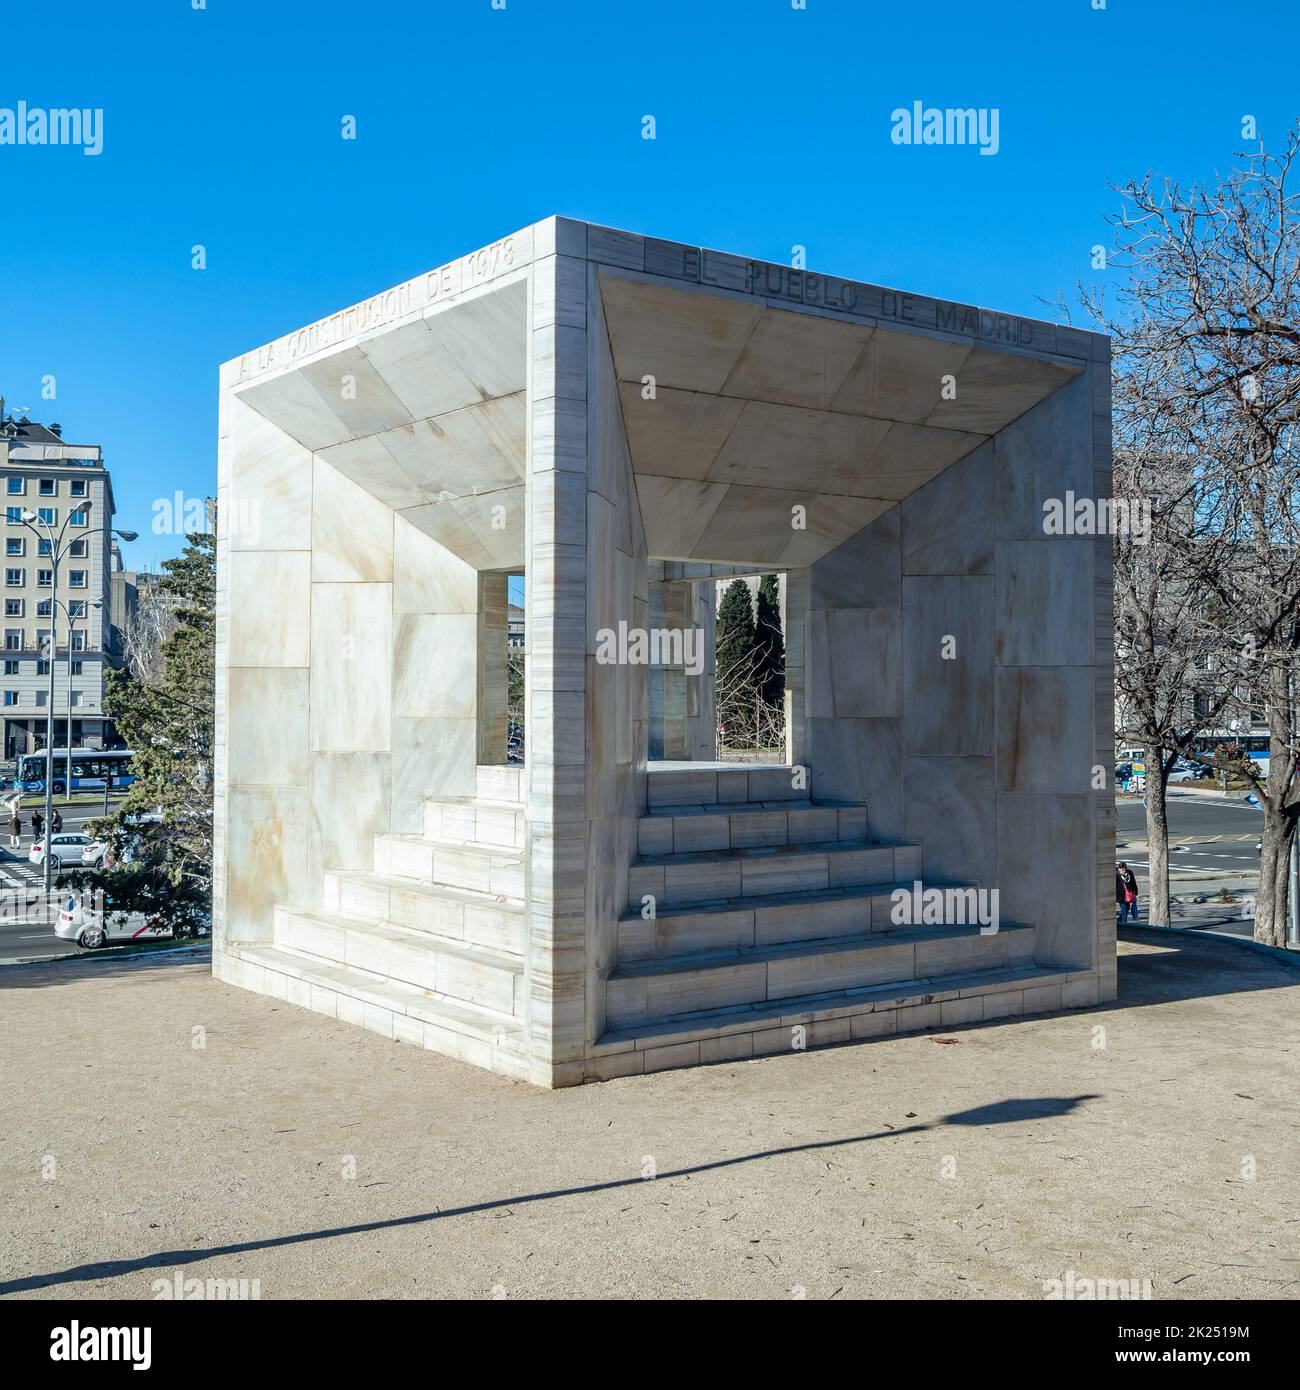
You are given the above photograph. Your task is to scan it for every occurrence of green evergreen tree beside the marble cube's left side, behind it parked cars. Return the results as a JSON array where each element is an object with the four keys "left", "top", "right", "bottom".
[{"left": 78, "top": 531, "right": 217, "bottom": 931}]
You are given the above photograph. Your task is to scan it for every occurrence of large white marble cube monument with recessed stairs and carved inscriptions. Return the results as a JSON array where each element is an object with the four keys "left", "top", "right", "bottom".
[{"left": 213, "top": 218, "right": 1115, "bottom": 1086}]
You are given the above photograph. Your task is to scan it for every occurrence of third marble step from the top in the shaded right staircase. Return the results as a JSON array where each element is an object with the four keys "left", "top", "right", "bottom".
[{"left": 627, "top": 840, "right": 920, "bottom": 913}]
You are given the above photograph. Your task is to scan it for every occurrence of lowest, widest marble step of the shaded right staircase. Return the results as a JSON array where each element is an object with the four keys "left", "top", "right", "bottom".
[{"left": 596, "top": 965, "right": 1089, "bottom": 1062}]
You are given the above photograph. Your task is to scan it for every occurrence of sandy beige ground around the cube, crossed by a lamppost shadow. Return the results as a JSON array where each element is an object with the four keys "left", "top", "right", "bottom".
[{"left": 0, "top": 935, "right": 1300, "bottom": 1298}]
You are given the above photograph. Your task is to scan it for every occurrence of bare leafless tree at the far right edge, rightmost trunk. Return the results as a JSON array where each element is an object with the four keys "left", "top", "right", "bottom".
[{"left": 1086, "top": 125, "right": 1300, "bottom": 944}]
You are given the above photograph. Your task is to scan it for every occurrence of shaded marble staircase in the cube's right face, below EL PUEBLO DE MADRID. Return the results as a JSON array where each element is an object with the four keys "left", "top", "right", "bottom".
[{"left": 595, "top": 763, "right": 1069, "bottom": 1074}]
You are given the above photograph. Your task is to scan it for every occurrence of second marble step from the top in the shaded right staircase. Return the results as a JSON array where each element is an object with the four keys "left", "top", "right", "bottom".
[{"left": 637, "top": 801, "right": 866, "bottom": 855}]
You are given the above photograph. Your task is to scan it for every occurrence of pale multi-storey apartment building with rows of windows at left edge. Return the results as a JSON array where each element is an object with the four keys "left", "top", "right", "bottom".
[{"left": 0, "top": 398, "right": 121, "bottom": 758}]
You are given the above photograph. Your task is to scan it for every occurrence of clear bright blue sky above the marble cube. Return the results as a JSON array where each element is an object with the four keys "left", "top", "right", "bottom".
[{"left": 0, "top": 0, "right": 1300, "bottom": 566}]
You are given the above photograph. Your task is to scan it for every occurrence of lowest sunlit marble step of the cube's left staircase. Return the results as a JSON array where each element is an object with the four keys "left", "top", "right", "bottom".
[{"left": 239, "top": 944, "right": 527, "bottom": 1052}]
